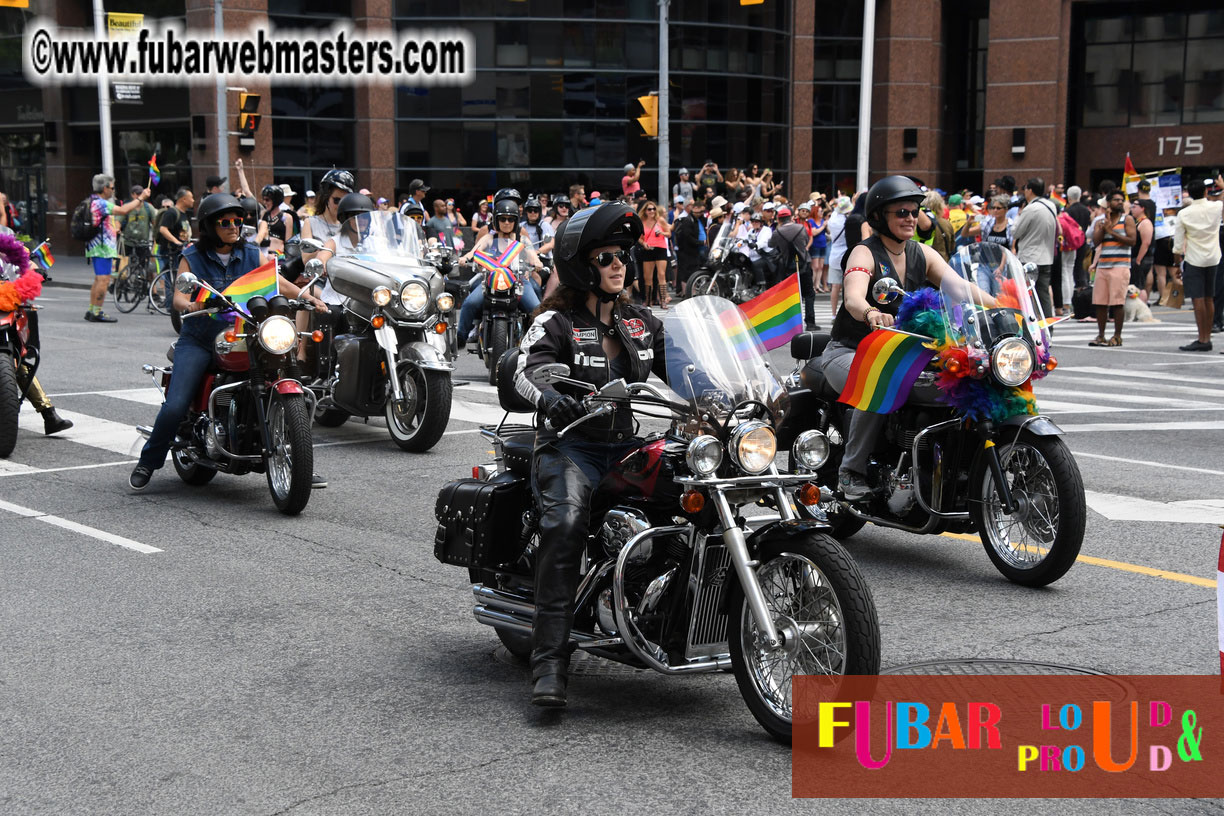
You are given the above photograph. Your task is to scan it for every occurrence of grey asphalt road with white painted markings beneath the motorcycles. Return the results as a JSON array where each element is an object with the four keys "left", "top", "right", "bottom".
[{"left": 0, "top": 281, "right": 1224, "bottom": 815}]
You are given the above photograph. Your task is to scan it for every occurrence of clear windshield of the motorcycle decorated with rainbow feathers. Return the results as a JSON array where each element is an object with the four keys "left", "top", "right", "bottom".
[{"left": 940, "top": 242, "right": 1050, "bottom": 356}]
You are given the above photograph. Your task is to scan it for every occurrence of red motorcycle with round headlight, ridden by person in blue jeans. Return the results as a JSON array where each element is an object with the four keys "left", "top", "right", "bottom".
[{"left": 137, "top": 267, "right": 315, "bottom": 515}]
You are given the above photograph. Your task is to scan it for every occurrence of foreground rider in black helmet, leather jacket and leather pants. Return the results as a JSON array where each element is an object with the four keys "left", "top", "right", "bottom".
[{"left": 514, "top": 203, "right": 666, "bottom": 706}]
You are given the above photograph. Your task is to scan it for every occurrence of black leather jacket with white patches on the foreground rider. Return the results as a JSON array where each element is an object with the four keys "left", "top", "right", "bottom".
[{"left": 514, "top": 303, "right": 667, "bottom": 444}]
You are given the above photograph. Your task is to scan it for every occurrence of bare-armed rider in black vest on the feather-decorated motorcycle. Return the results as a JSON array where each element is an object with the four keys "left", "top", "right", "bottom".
[{"left": 821, "top": 176, "right": 989, "bottom": 502}]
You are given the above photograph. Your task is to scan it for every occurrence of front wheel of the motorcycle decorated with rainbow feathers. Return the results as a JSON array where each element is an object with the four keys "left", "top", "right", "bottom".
[{"left": 969, "top": 432, "right": 1088, "bottom": 586}]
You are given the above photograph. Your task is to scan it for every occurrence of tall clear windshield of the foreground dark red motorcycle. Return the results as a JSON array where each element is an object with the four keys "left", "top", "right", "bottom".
[{"left": 663, "top": 296, "right": 787, "bottom": 422}]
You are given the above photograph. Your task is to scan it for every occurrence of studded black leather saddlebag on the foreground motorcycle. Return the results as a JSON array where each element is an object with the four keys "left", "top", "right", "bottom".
[{"left": 433, "top": 473, "right": 531, "bottom": 566}]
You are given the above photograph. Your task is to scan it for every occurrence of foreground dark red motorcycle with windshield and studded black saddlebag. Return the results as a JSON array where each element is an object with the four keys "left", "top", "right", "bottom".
[{"left": 435, "top": 297, "right": 880, "bottom": 743}]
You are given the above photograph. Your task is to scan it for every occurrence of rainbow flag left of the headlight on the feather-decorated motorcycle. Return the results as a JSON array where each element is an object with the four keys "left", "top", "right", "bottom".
[{"left": 837, "top": 329, "right": 935, "bottom": 414}]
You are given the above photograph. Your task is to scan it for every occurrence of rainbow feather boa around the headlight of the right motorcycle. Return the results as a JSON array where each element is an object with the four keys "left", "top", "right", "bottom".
[{"left": 896, "top": 281, "right": 1049, "bottom": 422}]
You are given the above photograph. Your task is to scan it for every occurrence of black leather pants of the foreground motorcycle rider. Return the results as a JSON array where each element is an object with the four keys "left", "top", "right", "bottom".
[{"left": 531, "top": 445, "right": 592, "bottom": 679}]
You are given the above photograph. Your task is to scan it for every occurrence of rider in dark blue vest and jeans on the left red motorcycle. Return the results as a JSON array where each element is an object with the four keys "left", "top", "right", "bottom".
[{"left": 129, "top": 193, "right": 327, "bottom": 491}]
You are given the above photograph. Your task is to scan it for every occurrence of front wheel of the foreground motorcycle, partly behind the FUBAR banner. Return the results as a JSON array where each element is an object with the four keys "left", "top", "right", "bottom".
[{"left": 727, "top": 533, "right": 880, "bottom": 745}]
